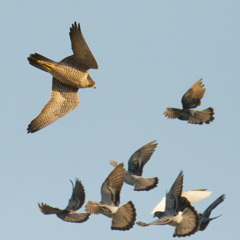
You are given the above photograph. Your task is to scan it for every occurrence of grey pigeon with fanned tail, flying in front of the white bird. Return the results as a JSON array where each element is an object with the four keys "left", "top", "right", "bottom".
[{"left": 137, "top": 171, "right": 200, "bottom": 237}]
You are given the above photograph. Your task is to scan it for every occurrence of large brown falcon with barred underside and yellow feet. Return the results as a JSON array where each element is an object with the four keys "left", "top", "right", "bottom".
[{"left": 27, "top": 22, "right": 98, "bottom": 133}]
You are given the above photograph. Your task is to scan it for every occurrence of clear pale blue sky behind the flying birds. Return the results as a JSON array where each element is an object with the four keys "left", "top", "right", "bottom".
[{"left": 0, "top": 0, "right": 240, "bottom": 240}]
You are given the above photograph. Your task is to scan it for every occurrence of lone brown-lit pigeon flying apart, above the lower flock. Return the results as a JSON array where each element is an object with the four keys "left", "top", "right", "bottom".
[{"left": 163, "top": 78, "right": 214, "bottom": 125}]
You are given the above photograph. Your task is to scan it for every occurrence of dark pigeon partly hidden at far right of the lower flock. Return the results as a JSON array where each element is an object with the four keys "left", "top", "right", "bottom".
[{"left": 198, "top": 194, "right": 225, "bottom": 231}]
